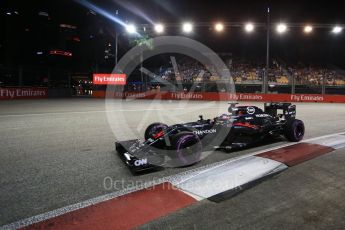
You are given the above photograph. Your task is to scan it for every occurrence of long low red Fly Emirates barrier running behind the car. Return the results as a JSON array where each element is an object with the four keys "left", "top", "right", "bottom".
[{"left": 92, "top": 91, "right": 345, "bottom": 103}]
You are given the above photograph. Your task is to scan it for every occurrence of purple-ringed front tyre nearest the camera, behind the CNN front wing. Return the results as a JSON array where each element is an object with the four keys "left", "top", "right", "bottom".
[{"left": 168, "top": 131, "right": 202, "bottom": 167}]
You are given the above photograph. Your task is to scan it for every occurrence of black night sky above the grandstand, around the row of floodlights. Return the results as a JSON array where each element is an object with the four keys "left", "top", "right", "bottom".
[{"left": 1, "top": 0, "right": 345, "bottom": 70}]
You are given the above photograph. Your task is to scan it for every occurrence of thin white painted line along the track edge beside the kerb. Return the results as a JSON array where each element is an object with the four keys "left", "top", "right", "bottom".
[{"left": 0, "top": 132, "right": 345, "bottom": 229}]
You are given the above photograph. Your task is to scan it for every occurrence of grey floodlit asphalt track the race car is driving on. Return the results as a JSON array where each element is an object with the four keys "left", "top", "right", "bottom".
[{"left": 0, "top": 98, "right": 345, "bottom": 227}]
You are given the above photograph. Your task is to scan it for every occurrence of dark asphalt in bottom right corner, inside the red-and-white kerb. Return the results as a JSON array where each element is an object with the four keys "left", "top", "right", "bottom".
[{"left": 139, "top": 150, "right": 345, "bottom": 230}]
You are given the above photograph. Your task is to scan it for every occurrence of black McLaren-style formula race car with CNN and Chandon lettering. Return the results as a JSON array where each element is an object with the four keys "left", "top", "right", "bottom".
[{"left": 115, "top": 103, "right": 305, "bottom": 173}]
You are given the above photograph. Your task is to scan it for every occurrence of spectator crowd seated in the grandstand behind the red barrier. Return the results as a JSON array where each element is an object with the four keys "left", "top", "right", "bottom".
[{"left": 152, "top": 57, "right": 345, "bottom": 86}]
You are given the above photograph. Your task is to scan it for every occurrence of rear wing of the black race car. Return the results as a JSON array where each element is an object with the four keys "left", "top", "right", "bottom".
[{"left": 265, "top": 102, "right": 296, "bottom": 120}]
